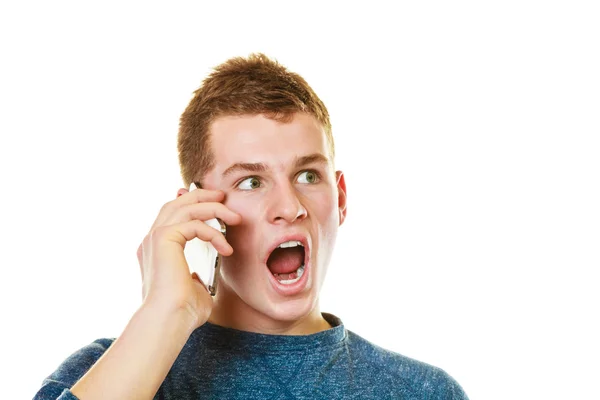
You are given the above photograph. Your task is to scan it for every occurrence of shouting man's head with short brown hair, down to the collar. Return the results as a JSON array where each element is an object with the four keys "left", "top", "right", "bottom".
[{"left": 178, "top": 55, "right": 346, "bottom": 329}]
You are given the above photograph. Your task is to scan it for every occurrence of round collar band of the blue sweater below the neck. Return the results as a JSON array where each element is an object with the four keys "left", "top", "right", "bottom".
[{"left": 188, "top": 313, "right": 346, "bottom": 353}]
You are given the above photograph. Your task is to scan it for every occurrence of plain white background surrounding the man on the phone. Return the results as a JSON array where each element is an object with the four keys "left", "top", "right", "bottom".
[{"left": 0, "top": 1, "right": 600, "bottom": 399}]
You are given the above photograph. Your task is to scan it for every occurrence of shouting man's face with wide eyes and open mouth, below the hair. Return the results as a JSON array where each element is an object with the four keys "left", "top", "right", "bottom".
[{"left": 203, "top": 114, "right": 346, "bottom": 321}]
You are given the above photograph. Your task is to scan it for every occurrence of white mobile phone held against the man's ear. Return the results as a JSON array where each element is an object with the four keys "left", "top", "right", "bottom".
[{"left": 183, "top": 182, "right": 227, "bottom": 296}]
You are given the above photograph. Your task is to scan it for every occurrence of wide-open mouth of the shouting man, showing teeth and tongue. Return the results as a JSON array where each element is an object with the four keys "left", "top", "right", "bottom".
[{"left": 267, "top": 240, "right": 306, "bottom": 285}]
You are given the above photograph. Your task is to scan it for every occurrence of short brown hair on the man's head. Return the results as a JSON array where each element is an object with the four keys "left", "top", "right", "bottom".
[{"left": 177, "top": 53, "right": 334, "bottom": 187}]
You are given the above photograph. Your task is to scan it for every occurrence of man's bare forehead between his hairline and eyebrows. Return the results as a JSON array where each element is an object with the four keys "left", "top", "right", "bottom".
[{"left": 210, "top": 113, "right": 329, "bottom": 173}]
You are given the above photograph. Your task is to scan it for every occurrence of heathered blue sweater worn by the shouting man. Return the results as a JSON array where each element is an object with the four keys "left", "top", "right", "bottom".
[{"left": 34, "top": 313, "right": 467, "bottom": 400}]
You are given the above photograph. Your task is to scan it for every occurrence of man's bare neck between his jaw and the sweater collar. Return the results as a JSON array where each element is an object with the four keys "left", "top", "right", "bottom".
[{"left": 208, "top": 285, "right": 331, "bottom": 335}]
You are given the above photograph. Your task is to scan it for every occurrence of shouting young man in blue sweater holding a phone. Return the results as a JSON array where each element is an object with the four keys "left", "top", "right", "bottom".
[{"left": 36, "top": 54, "right": 466, "bottom": 399}]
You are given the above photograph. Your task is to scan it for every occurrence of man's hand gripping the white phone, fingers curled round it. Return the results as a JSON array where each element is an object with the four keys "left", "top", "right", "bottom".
[{"left": 137, "top": 189, "right": 241, "bottom": 327}]
